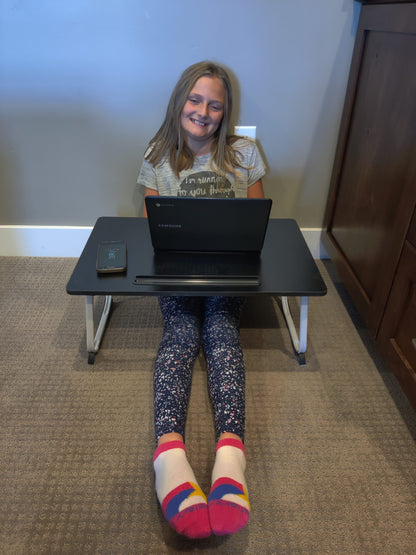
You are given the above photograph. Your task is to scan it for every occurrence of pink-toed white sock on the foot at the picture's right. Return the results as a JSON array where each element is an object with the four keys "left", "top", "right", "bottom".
[{"left": 208, "top": 439, "right": 250, "bottom": 536}]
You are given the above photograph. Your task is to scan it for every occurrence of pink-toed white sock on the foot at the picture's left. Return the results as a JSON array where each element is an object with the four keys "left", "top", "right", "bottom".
[{"left": 153, "top": 441, "right": 212, "bottom": 538}]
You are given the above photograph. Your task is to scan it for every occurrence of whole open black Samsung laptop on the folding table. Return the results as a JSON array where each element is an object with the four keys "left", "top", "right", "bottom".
[{"left": 136, "top": 196, "right": 272, "bottom": 287}]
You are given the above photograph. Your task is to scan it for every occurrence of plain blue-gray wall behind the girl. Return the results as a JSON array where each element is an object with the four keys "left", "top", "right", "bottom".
[{"left": 0, "top": 0, "right": 360, "bottom": 227}]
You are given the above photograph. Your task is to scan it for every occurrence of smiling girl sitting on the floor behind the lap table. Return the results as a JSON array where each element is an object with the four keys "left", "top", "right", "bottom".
[{"left": 138, "top": 62, "right": 265, "bottom": 538}]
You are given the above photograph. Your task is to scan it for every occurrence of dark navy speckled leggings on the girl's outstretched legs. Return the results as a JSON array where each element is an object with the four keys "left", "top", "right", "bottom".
[{"left": 154, "top": 297, "right": 245, "bottom": 440}]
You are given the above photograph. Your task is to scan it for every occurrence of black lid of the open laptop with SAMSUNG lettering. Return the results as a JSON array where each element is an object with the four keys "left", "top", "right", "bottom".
[{"left": 145, "top": 196, "right": 272, "bottom": 252}]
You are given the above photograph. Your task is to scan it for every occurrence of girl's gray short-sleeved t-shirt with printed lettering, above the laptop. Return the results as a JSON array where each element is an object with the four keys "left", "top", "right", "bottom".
[{"left": 137, "top": 138, "right": 266, "bottom": 198}]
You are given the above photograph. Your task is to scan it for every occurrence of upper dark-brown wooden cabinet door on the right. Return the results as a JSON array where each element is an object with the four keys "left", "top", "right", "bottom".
[{"left": 325, "top": 3, "right": 416, "bottom": 335}]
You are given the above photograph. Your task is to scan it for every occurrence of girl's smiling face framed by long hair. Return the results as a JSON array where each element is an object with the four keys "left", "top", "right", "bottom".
[{"left": 181, "top": 77, "right": 225, "bottom": 155}]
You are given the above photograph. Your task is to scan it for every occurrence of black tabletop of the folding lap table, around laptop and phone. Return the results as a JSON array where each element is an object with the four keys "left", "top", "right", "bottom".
[{"left": 67, "top": 217, "right": 327, "bottom": 296}]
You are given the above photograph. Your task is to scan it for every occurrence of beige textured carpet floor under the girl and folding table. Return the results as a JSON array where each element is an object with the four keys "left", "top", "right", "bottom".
[{"left": 0, "top": 258, "right": 416, "bottom": 555}]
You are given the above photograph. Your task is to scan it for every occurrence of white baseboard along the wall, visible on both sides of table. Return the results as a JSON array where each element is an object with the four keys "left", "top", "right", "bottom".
[{"left": 0, "top": 225, "right": 328, "bottom": 259}]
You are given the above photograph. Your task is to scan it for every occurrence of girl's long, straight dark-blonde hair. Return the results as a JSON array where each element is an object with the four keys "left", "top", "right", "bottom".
[{"left": 145, "top": 61, "right": 242, "bottom": 176}]
